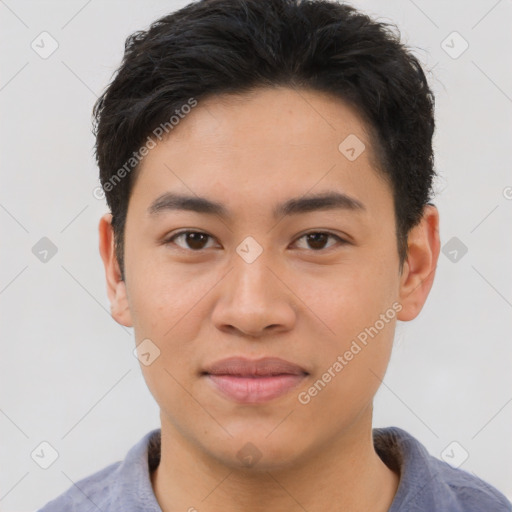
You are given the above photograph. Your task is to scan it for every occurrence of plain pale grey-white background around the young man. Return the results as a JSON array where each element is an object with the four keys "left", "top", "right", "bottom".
[{"left": 0, "top": 0, "right": 512, "bottom": 511}]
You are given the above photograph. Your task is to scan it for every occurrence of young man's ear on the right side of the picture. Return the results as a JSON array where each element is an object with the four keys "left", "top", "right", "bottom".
[{"left": 397, "top": 204, "right": 440, "bottom": 321}]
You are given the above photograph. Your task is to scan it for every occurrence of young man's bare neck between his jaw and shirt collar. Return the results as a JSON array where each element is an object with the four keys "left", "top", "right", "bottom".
[{"left": 151, "top": 410, "right": 399, "bottom": 512}]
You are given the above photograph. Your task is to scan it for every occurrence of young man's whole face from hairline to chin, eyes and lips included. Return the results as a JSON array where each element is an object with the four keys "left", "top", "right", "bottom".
[{"left": 102, "top": 88, "right": 440, "bottom": 469}]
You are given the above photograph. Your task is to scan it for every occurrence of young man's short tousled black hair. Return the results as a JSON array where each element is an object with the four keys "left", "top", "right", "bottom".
[{"left": 93, "top": 0, "right": 435, "bottom": 278}]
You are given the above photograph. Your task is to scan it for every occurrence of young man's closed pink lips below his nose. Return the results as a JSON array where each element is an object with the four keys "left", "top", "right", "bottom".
[{"left": 202, "top": 357, "right": 308, "bottom": 404}]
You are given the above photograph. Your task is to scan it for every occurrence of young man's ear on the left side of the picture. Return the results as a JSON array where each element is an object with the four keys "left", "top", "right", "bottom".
[{"left": 98, "top": 213, "right": 133, "bottom": 327}]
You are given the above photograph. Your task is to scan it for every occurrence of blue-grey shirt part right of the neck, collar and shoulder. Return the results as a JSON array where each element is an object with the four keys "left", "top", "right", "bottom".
[{"left": 373, "top": 427, "right": 512, "bottom": 512}]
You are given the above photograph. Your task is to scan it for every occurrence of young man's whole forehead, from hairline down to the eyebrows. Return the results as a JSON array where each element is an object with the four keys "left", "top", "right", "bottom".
[{"left": 133, "top": 87, "right": 391, "bottom": 220}]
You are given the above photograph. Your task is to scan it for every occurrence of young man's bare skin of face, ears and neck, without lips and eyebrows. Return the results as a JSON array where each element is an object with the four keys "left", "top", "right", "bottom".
[{"left": 99, "top": 88, "right": 439, "bottom": 512}]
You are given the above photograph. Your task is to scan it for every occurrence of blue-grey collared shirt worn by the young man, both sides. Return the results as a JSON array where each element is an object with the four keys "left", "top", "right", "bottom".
[{"left": 38, "top": 427, "right": 512, "bottom": 512}]
